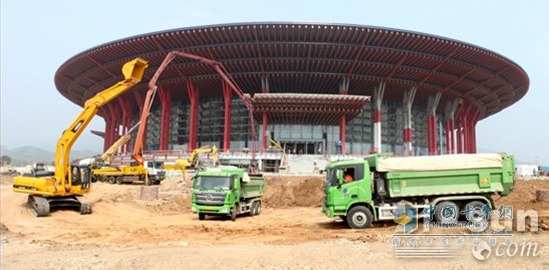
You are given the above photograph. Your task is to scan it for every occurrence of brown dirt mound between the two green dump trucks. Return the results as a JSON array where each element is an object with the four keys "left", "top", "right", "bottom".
[{"left": 263, "top": 176, "right": 324, "bottom": 208}]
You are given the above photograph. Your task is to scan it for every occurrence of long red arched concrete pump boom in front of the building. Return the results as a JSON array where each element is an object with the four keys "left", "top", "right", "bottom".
[{"left": 133, "top": 51, "right": 256, "bottom": 164}]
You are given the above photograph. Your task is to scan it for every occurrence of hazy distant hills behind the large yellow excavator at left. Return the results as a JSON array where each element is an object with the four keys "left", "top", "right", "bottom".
[{"left": 0, "top": 145, "right": 98, "bottom": 166}]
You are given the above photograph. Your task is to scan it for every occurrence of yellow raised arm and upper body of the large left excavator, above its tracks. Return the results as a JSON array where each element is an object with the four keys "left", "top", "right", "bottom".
[{"left": 13, "top": 58, "right": 148, "bottom": 216}]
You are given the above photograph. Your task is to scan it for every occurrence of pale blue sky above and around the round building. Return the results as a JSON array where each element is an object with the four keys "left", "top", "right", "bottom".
[{"left": 0, "top": 0, "right": 549, "bottom": 166}]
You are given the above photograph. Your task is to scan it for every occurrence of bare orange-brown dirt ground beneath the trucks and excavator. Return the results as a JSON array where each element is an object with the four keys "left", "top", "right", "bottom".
[{"left": 1, "top": 176, "right": 549, "bottom": 269}]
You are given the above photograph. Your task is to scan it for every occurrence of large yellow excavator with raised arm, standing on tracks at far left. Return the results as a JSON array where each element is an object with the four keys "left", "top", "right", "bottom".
[{"left": 13, "top": 58, "right": 148, "bottom": 217}]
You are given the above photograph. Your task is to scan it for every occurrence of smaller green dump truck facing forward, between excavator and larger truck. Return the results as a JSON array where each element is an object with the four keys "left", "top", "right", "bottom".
[{"left": 191, "top": 166, "right": 265, "bottom": 221}]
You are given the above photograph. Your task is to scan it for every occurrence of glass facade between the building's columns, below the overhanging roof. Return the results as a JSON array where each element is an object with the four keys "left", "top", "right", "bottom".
[{"left": 141, "top": 98, "right": 446, "bottom": 155}]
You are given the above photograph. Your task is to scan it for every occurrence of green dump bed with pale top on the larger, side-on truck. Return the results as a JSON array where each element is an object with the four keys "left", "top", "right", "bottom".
[{"left": 366, "top": 154, "right": 515, "bottom": 197}]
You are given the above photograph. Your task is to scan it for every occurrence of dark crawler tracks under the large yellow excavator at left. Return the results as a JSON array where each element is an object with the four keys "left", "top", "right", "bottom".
[{"left": 28, "top": 195, "right": 92, "bottom": 217}]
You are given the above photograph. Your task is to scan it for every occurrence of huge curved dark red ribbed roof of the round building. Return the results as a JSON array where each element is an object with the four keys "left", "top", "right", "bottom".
[{"left": 55, "top": 23, "right": 529, "bottom": 119}]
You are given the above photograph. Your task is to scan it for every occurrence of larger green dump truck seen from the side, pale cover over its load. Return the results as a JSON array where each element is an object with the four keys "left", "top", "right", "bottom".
[{"left": 322, "top": 154, "right": 515, "bottom": 229}]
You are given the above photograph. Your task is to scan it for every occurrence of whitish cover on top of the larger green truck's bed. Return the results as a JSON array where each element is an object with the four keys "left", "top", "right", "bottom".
[{"left": 377, "top": 154, "right": 503, "bottom": 172}]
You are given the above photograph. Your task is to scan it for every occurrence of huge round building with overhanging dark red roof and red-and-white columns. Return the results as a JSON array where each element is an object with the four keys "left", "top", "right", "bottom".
[{"left": 55, "top": 23, "right": 529, "bottom": 162}]
